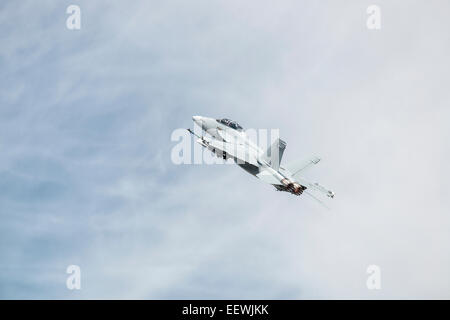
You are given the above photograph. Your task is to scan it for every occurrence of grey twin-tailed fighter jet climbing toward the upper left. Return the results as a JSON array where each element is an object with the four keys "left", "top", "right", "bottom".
[{"left": 187, "top": 116, "right": 334, "bottom": 204}]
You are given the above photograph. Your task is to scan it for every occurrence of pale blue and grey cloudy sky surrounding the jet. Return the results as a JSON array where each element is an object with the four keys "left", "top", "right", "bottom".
[{"left": 0, "top": 0, "right": 450, "bottom": 299}]
